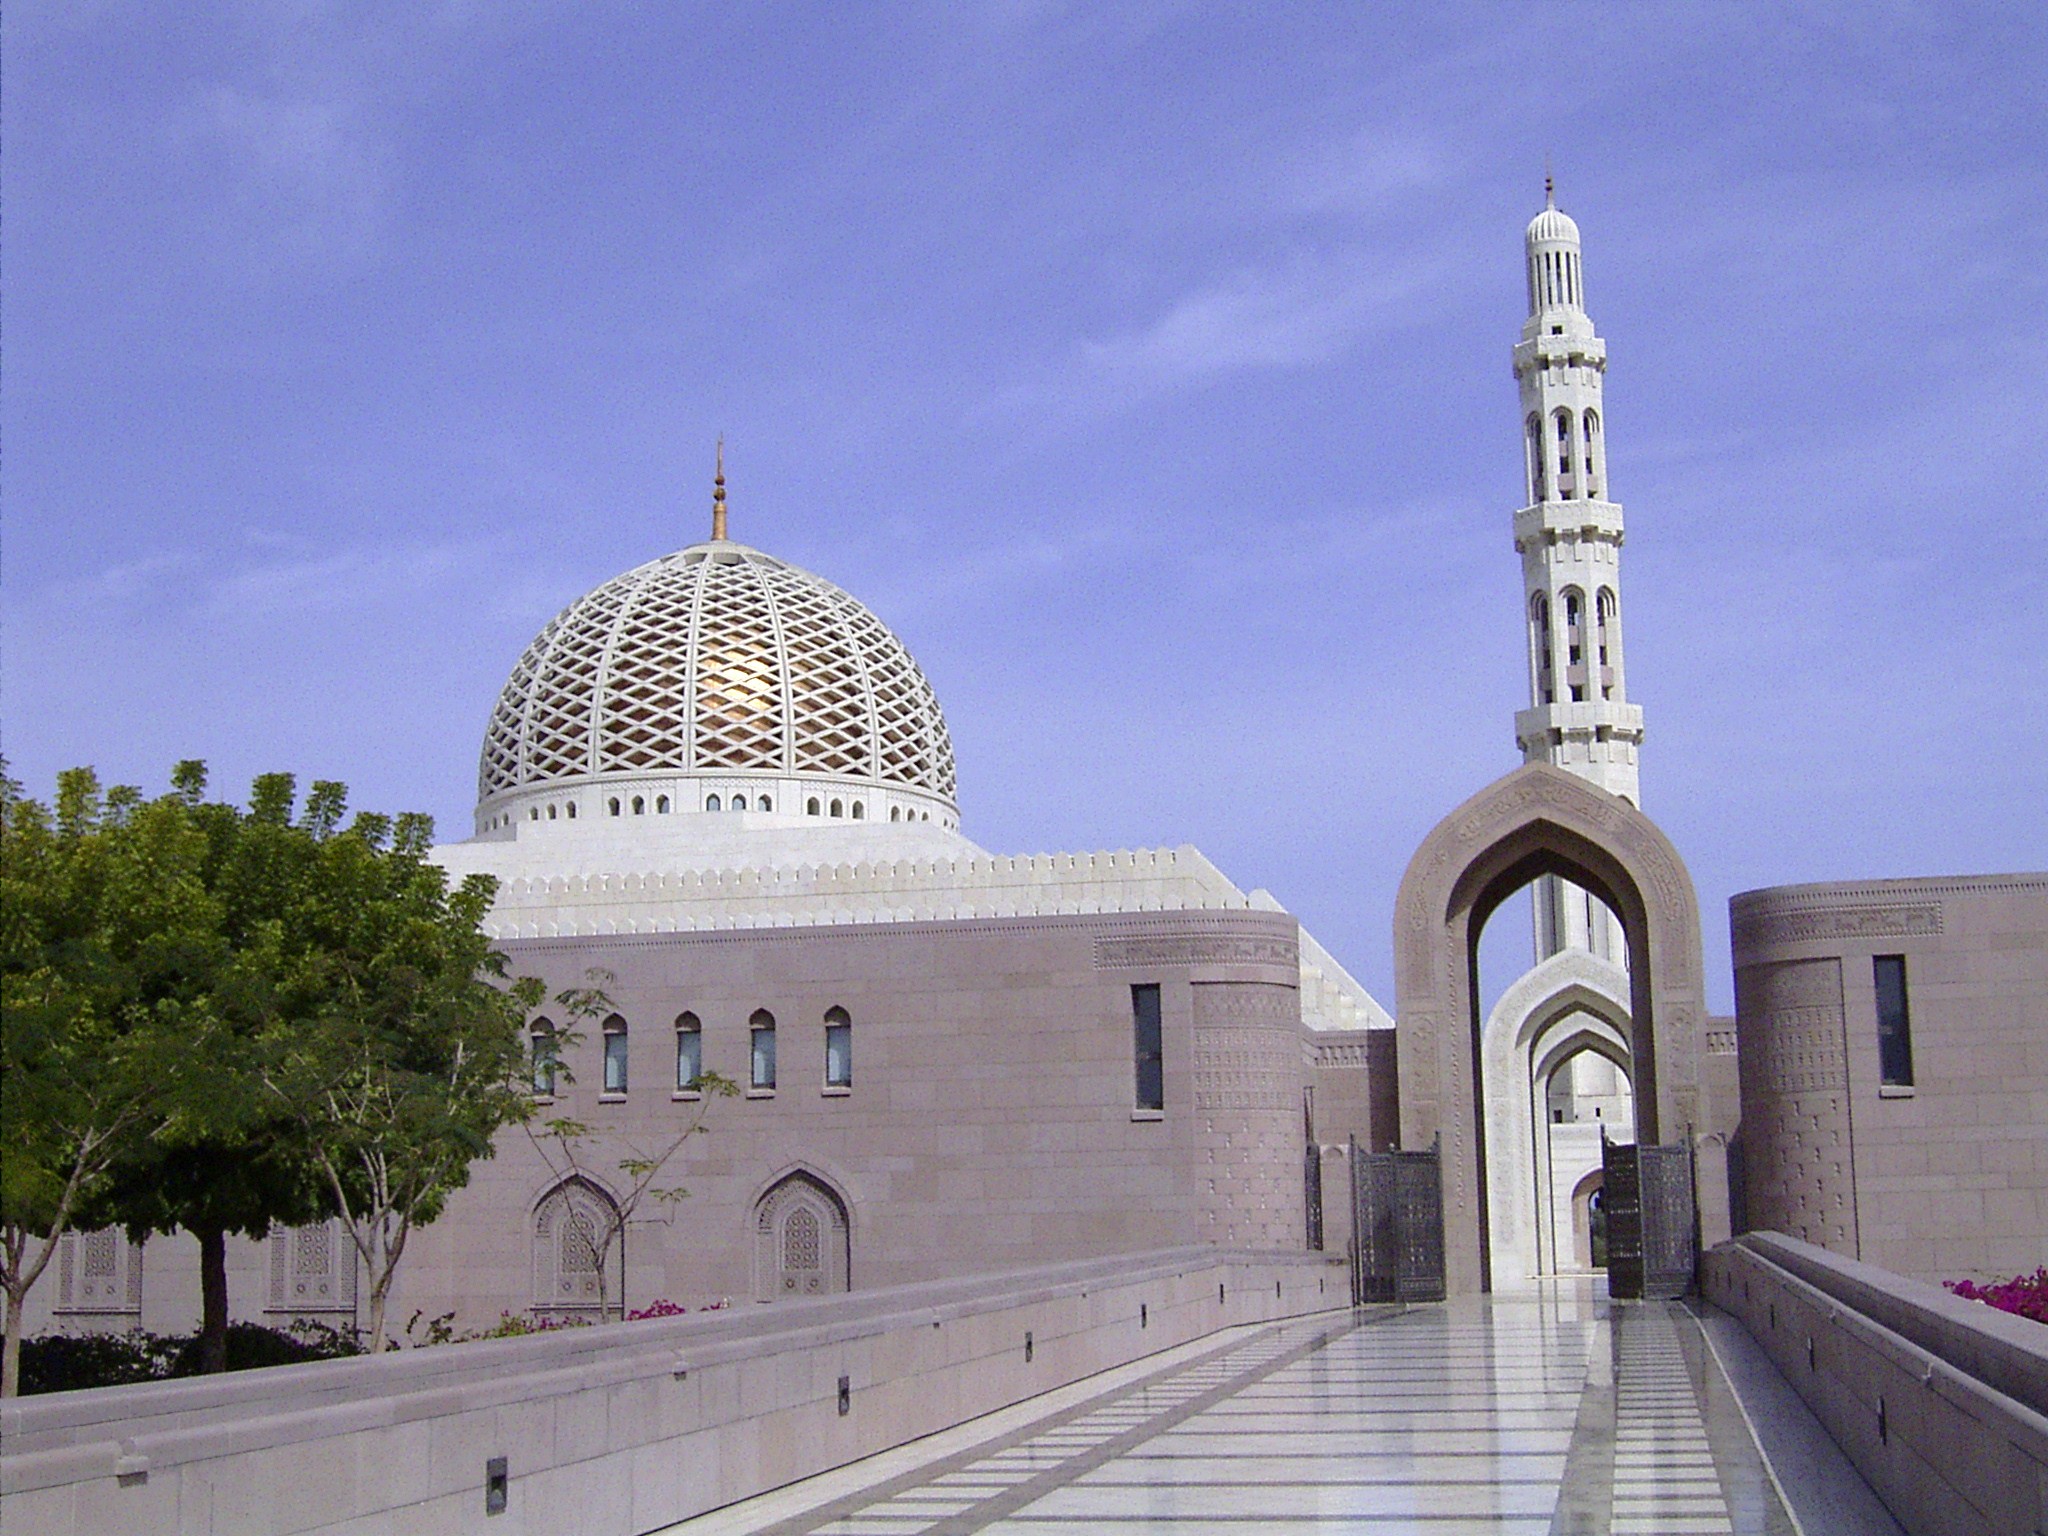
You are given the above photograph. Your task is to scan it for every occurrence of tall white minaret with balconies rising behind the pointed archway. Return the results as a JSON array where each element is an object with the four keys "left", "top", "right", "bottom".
[{"left": 1516, "top": 186, "right": 1642, "bottom": 965}]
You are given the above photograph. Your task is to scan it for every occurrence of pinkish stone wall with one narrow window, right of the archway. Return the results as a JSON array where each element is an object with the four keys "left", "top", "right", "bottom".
[{"left": 1731, "top": 874, "right": 2048, "bottom": 1280}]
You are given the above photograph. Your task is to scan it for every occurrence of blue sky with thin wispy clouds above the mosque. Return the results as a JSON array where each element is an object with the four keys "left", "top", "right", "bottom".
[{"left": 0, "top": 0, "right": 2048, "bottom": 1008}]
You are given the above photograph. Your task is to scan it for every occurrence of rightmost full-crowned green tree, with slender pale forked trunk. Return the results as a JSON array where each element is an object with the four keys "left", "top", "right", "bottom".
[{"left": 262, "top": 798, "right": 541, "bottom": 1350}]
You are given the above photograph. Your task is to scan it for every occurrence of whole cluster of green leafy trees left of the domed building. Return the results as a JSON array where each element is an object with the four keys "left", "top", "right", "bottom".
[{"left": 0, "top": 762, "right": 544, "bottom": 1397}]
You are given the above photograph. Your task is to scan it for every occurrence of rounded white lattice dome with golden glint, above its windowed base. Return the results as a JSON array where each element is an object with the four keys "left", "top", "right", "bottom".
[{"left": 477, "top": 541, "right": 954, "bottom": 805}]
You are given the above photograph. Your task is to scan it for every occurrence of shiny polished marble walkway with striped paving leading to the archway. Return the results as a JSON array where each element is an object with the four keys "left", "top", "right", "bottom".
[{"left": 672, "top": 1282, "right": 1896, "bottom": 1536}]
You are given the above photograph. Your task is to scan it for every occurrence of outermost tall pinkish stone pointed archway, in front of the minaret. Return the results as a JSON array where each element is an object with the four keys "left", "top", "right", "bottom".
[{"left": 1395, "top": 762, "right": 1726, "bottom": 1294}]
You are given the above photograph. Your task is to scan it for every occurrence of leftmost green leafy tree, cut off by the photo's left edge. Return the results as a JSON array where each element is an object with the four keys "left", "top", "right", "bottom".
[{"left": 0, "top": 768, "right": 215, "bottom": 1397}]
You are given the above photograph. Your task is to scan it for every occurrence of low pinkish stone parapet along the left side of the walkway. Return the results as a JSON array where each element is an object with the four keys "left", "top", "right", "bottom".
[{"left": 0, "top": 1249, "right": 1350, "bottom": 1536}]
